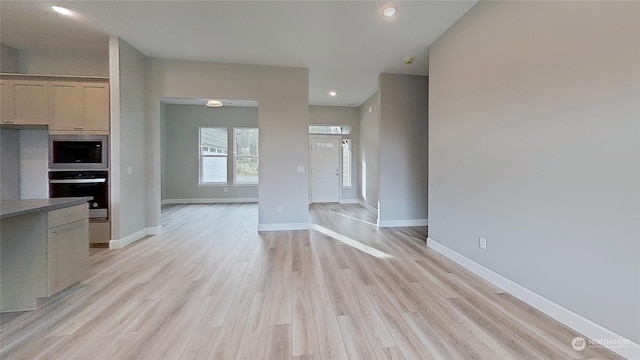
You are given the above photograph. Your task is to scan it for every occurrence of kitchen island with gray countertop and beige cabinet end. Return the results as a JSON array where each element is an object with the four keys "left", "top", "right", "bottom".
[{"left": 0, "top": 197, "right": 90, "bottom": 313}]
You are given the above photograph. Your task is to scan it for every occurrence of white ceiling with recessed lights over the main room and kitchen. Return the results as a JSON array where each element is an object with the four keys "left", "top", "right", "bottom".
[{"left": 0, "top": 0, "right": 477, "bottom": 106}]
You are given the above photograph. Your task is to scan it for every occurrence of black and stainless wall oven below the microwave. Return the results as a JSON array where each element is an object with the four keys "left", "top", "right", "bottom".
[{"left": 49, "top": 171, "right": 109, "bottom": 220}]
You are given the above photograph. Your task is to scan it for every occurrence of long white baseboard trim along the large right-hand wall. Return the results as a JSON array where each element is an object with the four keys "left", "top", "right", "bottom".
[{"left": 427, "top": 238, "right": 640, "bottom": 359}]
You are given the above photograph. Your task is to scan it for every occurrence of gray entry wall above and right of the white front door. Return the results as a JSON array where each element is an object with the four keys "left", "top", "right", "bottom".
[{"left": 309, "top": 105, "right": 360, "bottom": 201}]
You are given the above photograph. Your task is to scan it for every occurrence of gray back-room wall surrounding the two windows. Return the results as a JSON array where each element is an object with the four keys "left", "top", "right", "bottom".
[{"left": 162, "top": 104, "right": 258, "bottom": 201}]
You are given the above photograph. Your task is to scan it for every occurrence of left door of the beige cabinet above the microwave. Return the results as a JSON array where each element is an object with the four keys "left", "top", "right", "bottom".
[{"left": 49, "top": 82, "right": 83, "bottom": 131}]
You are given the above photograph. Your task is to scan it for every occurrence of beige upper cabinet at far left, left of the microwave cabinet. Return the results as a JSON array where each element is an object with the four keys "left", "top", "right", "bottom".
[{"left": 0, "top": 79, "right": 49, "bottom": 125}]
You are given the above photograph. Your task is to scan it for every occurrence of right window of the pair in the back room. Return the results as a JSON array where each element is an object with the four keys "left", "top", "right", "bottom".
[{"left": 233, "top": 128, "right": 259, "bottom": 185}]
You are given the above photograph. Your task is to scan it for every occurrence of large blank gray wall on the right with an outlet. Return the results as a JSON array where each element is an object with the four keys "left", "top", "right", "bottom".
[{"left": 429, "top": 2, "right": 640, "bottom": 343}]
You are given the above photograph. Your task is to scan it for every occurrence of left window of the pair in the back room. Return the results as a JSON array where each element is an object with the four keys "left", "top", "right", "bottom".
[{"left": 200, "top": 127, "right": 229, "bottom": 184}]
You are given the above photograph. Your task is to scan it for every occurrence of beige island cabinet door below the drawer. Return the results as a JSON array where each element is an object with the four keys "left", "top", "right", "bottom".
[{"left": 47, "top": 219, "right": 89, "bottom": 296}]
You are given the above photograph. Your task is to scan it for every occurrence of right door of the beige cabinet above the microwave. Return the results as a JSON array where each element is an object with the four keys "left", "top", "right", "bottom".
[{"left": 82, "top": 83, "right": 110, "bottom": 131}]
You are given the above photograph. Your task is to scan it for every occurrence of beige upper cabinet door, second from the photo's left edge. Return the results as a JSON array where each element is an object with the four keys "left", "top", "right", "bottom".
[{"left": 12, "top": 80, "right": 49, "bottom": 125}]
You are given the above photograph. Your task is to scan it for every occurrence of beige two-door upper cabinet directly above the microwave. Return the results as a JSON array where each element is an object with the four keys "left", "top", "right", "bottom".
[{"left": 49, "top": 81, "right": 109, "bottom": 134}]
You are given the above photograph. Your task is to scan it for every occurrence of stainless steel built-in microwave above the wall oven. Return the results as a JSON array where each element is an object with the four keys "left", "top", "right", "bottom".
[{"left": 49, "top": 135, "right": 109, "bottom": 170}]
